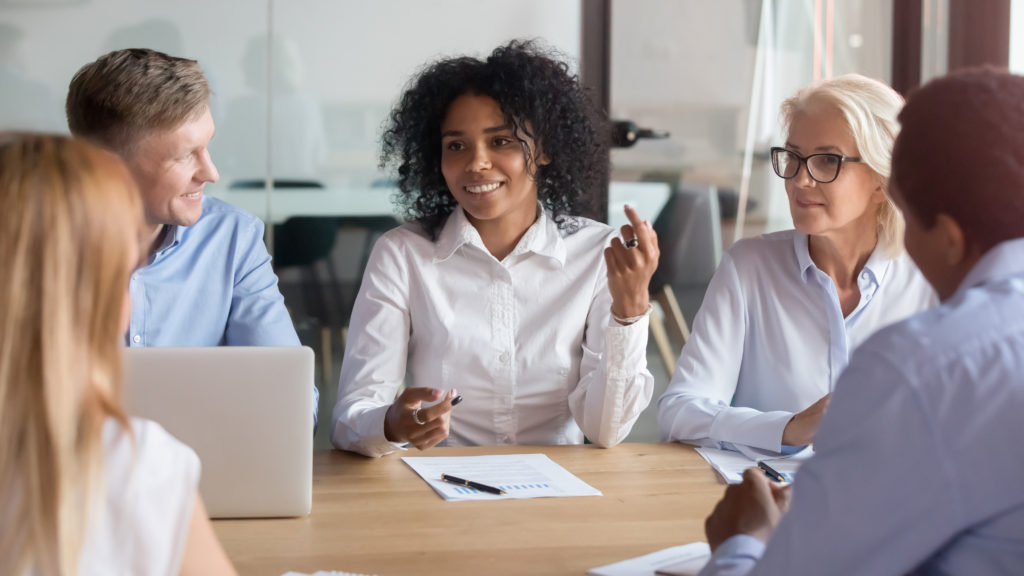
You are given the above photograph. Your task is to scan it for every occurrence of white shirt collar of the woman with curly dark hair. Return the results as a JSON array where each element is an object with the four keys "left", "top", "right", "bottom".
[{"left": 434, "top": 204, "right": 565, "bottom": 265}]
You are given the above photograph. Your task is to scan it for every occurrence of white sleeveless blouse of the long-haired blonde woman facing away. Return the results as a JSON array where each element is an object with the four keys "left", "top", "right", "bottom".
[{"left": 79, "top": 419, "right": 200, "bottom": 576}]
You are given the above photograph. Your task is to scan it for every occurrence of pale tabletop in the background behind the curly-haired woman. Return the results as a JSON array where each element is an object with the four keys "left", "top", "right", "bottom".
[{"left": 211, "top": 182, "right": 670, "bottom": 228}]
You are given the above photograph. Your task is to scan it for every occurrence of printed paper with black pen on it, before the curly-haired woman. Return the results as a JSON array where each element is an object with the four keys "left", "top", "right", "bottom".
[{"left": 402, "top": 454, "right": 601, "bottom": 500}]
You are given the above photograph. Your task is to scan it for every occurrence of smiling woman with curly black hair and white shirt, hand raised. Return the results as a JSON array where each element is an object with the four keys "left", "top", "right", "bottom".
[{"left": 332, "top": 41, "right": 658, "bottom": 456}]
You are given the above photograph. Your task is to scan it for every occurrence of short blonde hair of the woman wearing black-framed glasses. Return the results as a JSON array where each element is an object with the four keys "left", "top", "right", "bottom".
[{"left": 780, "top": 74, "right": 904, "bottom": 256}]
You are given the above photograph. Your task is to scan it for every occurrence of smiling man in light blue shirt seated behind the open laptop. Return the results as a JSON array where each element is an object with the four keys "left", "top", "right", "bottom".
[{"left": 66, "top": 48, "right": 319, "bottom": 417}]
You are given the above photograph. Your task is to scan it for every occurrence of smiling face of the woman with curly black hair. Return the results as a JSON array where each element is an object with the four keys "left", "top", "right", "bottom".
[{"left": 441, "top": 93, "right": 537, "bottom": 231}]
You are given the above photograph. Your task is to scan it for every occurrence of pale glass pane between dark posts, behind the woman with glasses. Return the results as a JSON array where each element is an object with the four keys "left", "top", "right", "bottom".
[{"left": 610, "top": 0, "right": 893, "bottom": 240}]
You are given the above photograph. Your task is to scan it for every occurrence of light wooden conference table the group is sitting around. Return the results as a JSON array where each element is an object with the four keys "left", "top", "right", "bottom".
[{"left": 213, "top": 443, "right": 724, "bottom": 576}]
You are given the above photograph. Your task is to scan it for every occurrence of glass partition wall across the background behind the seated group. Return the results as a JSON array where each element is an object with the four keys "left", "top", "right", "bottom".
[{"left": 0, "top": 0, "right": 950, "bottom": 446}]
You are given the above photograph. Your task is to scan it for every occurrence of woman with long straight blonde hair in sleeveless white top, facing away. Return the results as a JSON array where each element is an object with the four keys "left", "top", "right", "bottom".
[{"left": 0, "top": 134, "right": 234, "bottom": 576}]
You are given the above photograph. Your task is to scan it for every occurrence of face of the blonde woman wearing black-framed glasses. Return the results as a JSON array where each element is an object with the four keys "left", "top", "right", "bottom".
[{"left": 785, "top": 107, "right": 885, "bottom": 240}]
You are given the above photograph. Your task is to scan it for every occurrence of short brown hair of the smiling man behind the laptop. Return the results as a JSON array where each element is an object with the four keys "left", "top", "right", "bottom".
[{"left": 65, "top": 48, "right": 210, "bottom": 155}]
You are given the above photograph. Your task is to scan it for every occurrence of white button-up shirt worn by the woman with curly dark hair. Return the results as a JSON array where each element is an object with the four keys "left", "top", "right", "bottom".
[{"left": 332, "top": 209, "right": 653, "bottom": 456}]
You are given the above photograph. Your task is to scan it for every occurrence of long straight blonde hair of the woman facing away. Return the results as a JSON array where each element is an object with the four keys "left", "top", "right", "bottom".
[{"left": 0, "top": 134, "right": 142, "bottom": 576}]
